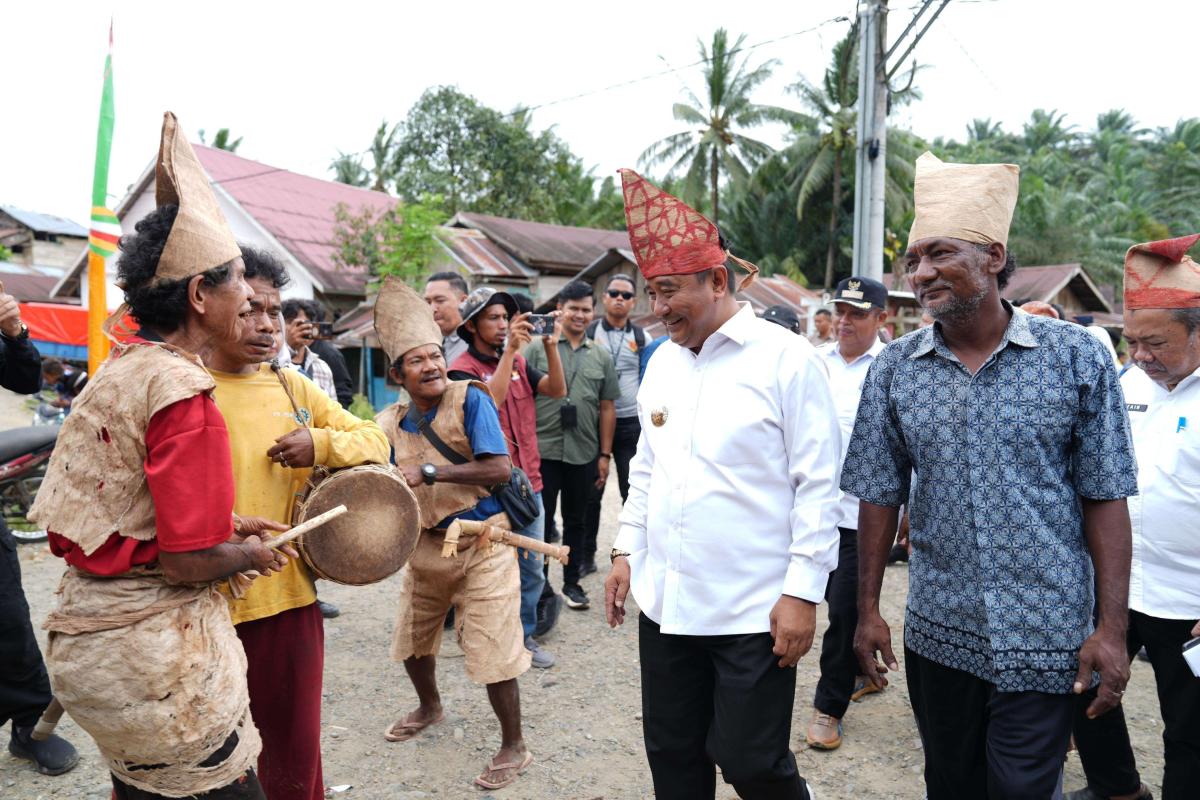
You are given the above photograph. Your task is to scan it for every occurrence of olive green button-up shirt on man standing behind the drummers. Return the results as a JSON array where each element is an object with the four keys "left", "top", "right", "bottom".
[{"left": 524, "top": 336, "right": 620, "bottom": 465}]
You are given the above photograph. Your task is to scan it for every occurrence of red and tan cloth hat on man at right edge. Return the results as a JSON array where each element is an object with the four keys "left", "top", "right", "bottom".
[{"left": 1124, "top": 234, "right": 1200, "bottom": 308}]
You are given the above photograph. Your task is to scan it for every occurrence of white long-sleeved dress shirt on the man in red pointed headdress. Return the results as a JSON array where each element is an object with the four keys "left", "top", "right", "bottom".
[{"left": 613, "top": 303, "right": 841, "bottom": 636}]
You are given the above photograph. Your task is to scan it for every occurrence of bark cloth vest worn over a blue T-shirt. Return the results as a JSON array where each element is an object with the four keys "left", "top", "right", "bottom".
[{"left": 376, "top": 380, "right": 492, "bottom": 529}]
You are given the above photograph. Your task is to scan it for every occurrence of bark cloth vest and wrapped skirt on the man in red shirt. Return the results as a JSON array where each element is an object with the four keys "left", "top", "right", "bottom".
[{"left": 30, "top": 344, "right": 262, "bottom": 798}]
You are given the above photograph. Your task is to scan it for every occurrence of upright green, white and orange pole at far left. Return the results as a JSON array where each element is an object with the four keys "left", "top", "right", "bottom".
[{"left": 88, "top": 20, "right": 121, "bottom": 375}]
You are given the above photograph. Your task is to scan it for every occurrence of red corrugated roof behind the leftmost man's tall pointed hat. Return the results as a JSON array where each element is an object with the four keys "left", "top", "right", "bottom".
[{"left": 192, "top": 144, "right": 396, "bottom": 294}]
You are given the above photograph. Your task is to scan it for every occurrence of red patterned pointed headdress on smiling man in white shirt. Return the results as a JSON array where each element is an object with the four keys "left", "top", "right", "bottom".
[{"left": 619, "top": 169, "right": 758, "bottom": 291}]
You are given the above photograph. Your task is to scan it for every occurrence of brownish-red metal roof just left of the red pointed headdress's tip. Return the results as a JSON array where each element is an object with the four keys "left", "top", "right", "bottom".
[{"left": 449, "top": 211, "right": 629, "bottom": 272}]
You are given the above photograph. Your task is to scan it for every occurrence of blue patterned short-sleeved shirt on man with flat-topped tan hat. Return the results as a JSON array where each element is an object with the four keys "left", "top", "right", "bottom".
[{"left": 841, "top": 303, "right": 1138, "bottom": 694}]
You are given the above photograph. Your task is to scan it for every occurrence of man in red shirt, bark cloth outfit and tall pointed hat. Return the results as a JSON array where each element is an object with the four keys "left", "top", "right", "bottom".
[{"left": 30, "top": 113, "right": 288, "bottom": 800}]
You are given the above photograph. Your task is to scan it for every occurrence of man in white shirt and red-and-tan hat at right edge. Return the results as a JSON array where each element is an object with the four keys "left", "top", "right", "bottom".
[{"left": 1068, "top": 234, "right": 1200, "bottom": 800}]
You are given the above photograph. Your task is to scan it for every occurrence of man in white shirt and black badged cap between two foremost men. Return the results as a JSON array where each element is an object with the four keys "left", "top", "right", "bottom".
[{"left": 804, "top": 277, "right": 888, "bottom": 750}]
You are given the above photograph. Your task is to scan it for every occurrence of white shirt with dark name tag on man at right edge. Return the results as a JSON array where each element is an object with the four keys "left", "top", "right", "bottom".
[{"left": 1121, "top": 367, "right": 1200, "bottom": 619}]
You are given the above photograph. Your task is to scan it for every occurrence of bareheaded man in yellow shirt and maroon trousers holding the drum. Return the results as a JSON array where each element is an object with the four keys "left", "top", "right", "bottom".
[{"left": 205, "top": 246, "right": 388, "bottom": 800}]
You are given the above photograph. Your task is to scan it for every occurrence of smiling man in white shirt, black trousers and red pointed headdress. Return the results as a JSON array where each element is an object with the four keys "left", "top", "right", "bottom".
[{"left": 605, "top": 169, "right": 841, "bottom": 800}]
